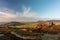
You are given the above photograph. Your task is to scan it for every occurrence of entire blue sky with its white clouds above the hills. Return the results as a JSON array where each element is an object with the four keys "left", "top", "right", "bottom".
[{"left": 0, "top": 0, "right": 60, "bottom": 22}]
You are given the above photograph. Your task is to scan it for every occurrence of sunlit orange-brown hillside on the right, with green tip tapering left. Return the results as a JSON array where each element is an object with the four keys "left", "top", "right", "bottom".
[{"left": 16, "top": 21, "right": 60, "bottom": 33}]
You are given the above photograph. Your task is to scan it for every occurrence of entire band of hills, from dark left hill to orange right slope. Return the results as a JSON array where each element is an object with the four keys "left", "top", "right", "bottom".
[{"left": 0, "top": 21, "right": 60, "bottom": 33}]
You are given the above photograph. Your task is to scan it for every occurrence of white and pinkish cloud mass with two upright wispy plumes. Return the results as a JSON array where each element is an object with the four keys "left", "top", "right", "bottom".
[{"left": 0, "top": 6, "right": 39, "bottom": 22}]
